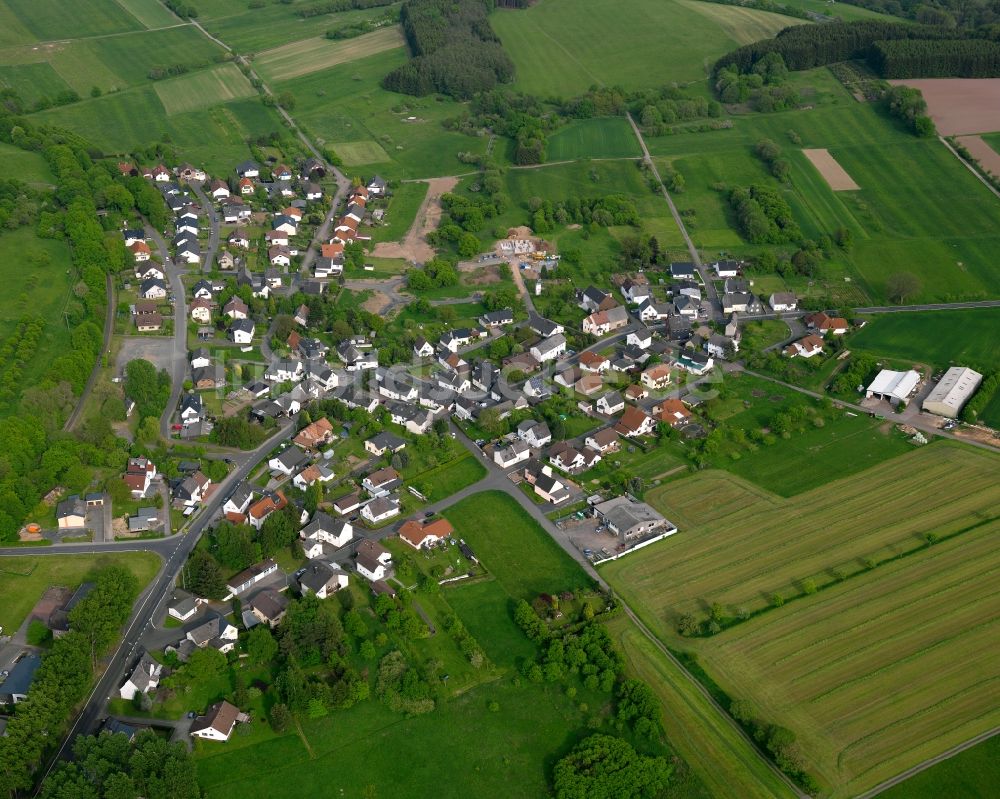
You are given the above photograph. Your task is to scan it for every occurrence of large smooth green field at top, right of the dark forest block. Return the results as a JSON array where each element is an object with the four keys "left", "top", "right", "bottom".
[{"left": 490, "top": 0, "right": 798, "bottom": 97}]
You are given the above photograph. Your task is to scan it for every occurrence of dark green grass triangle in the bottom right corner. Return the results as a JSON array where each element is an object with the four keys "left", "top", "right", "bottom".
[{"left": 879, "top": 735, "right": 1000, "bottom": 799}]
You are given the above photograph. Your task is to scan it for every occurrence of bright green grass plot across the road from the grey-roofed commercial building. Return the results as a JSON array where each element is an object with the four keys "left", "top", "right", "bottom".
[{"left": 442, "top": 491, "right": 589, "bottom": 599}]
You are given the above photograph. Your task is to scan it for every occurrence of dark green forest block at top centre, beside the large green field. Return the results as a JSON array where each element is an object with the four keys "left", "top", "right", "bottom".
[{"left": 382, "top": 0, "right": 514, "bottom": 100}]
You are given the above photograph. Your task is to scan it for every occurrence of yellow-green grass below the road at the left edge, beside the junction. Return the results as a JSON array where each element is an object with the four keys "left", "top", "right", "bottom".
[{"left": 0, "top": 552, "right": 162, "bottom": 634}]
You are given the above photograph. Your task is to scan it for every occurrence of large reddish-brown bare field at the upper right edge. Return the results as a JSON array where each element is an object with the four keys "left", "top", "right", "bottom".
[{"left": 889, "top": 78, "right": 1000, "bottom": 136}]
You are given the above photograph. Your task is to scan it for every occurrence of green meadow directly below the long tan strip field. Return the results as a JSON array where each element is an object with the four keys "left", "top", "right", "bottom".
[{"left": 271, "top": 47, "right": 487, "bottom": 179}]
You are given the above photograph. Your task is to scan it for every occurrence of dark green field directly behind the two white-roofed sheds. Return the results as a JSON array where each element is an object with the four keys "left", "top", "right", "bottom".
[{"left": 847, "top": 308, "right": 1000, "bottom": 372}]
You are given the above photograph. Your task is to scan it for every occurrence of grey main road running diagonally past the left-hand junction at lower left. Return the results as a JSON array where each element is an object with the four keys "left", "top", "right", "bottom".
[{"left": 37, "top": 420, "right": 295, "bottom": 777}]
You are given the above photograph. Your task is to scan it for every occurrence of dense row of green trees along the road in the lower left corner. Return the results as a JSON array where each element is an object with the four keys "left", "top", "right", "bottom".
[{"left": 0, "top": 566, "right": 139, "bottom": 795}]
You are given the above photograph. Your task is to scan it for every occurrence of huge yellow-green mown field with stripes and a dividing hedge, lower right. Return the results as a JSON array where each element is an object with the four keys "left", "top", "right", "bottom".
[{"left": 602, "top": 442, "right": 1000, "bottom": 797}]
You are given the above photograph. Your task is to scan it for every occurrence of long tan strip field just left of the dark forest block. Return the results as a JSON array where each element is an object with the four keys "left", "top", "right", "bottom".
[{"left": 254, "top": 25, "right": 404, "bottom": 81}]
